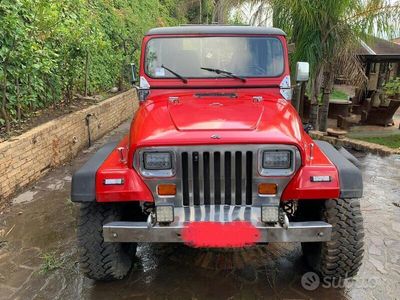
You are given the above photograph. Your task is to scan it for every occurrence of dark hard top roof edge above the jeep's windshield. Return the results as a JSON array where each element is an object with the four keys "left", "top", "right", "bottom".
[{"left": 147, "top": 25, "right": 286, "bottom": 35}]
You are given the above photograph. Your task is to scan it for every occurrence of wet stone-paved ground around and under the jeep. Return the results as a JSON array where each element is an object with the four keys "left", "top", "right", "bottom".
[{"left": 0, "top": 123, "right": 400, "bottom": 299}]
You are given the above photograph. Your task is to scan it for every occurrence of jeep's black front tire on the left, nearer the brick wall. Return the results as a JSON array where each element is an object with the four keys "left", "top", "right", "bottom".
[{"left": 78, "top": 203, "right": 137, "bottom": 281}]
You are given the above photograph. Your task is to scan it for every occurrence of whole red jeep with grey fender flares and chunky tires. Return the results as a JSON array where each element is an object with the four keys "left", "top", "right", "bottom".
[{"left": 71, "top": 26, "right": 364, "bottom": 280}]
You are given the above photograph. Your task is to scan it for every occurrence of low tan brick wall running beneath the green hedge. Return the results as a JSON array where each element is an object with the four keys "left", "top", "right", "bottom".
[{"left": 0, "top": 90, "right": 137, "bottom": 202}]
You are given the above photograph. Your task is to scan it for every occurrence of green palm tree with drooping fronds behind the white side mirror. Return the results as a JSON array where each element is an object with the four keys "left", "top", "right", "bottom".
[{"left": 239, "top": 0, "right": 400, "bottom": 131}]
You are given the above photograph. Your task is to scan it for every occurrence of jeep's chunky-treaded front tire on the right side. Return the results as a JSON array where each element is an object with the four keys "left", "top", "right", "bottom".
[{"left": 301, "top": 199, "right": 364, "bottom": 279}]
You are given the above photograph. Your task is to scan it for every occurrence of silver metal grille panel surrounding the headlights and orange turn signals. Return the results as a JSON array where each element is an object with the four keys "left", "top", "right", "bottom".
[{"left": 134, "top": 144, "right": 301, "bottom": 207}]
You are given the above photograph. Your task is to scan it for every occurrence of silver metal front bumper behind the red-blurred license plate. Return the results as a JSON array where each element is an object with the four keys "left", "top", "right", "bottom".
[{"left": 103, "top": 205, "right": 332, "bottom": 243}]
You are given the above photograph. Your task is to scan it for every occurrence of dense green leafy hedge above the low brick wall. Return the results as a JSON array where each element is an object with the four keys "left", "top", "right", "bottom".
[{"left": 0, "top": 0, "right": 185, "bottom": 131}]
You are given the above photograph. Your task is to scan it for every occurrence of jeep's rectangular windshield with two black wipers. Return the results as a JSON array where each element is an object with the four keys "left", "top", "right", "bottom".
[{"left": 145, "top": 36, "right": 284, "bottom": 78}]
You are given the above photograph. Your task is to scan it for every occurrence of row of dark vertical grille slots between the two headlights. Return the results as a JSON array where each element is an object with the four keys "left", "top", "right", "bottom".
[{"left": 178, "top": 151, "right": 254, "bottom": 206}]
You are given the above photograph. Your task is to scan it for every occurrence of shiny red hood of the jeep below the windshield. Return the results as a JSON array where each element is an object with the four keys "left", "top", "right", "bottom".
[{"left": 130, "top": 89, "right": 304, "bottom": 151}]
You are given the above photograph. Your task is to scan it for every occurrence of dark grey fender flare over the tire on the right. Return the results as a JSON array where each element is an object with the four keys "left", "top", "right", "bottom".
[{"left": 314, "top": 141, "right": 363, "bottom": 199}]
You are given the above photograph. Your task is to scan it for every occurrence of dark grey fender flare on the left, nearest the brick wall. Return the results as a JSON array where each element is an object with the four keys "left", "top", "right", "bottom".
[{"left": 71, "top": 142, "right": 118, "bottom": 202}]
